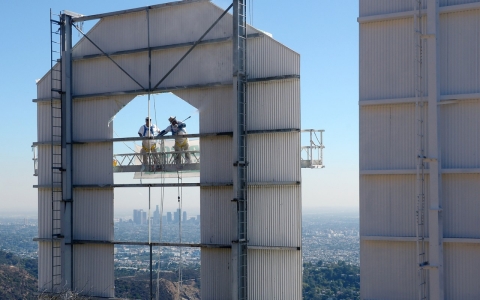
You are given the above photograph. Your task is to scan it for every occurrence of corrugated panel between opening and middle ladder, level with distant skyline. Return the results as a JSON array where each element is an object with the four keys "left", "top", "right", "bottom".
[{"left": 200, "top": 187, "right": 236, "bottom": 244}]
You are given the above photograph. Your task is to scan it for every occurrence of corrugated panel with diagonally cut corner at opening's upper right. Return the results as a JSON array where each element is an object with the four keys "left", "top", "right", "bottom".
[{"left": 173, "top": 86, "right": 233, "bottom": 133}]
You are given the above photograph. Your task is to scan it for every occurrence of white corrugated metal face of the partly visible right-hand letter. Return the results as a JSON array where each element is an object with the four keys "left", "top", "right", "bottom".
[{"left": 360, "top": 0, "right": 480, "bottom": 299}]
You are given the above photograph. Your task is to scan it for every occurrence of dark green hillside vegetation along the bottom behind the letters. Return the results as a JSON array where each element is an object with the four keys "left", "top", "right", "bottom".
[{"left": 0, "top": 251, "right": 360, "bottom": 300}]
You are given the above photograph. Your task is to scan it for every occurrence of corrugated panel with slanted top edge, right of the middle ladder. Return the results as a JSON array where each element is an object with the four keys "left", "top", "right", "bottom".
[{"left": 247, "top": 36, "right": 300, "bottom": 78}]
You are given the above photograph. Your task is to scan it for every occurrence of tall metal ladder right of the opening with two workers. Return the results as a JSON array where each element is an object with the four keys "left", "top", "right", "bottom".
[{"left": 234, "top": 0, "right": 248, "bottom": 300}]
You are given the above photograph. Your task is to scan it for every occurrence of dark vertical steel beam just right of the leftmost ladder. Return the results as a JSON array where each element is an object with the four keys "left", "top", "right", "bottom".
[{"left": 61, "top": 14, "right": 74, "bottom": 290}]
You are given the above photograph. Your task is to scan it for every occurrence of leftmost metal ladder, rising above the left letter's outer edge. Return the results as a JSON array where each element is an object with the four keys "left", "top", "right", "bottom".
[{"left": 50, "top": 10, "right": 63, "bottom": 293}]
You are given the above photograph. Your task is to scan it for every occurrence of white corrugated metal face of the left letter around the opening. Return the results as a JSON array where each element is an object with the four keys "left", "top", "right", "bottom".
[{"left": 38, "top": 1, "right": 301, "bottom": 299}]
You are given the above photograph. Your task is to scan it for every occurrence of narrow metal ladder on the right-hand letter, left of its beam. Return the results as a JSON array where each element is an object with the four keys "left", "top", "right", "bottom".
[{"left": 413, "top": 0, "right": 428, "bottom": 299}]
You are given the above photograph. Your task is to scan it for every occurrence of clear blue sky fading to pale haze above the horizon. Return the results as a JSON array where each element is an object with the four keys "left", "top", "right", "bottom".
[{"left": 0, "top": 0, "right": 359, "bottom": 216}]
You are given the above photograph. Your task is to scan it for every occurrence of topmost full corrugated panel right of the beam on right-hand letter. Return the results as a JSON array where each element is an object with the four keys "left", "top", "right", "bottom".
[{"left": 438, "top": 10, "right": 480, "bottom": 95}]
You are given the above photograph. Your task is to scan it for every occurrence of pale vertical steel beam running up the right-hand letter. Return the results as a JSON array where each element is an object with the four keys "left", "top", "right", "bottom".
[{"left": 427, "top": 0, "right": 444, "bottom": 300}]
